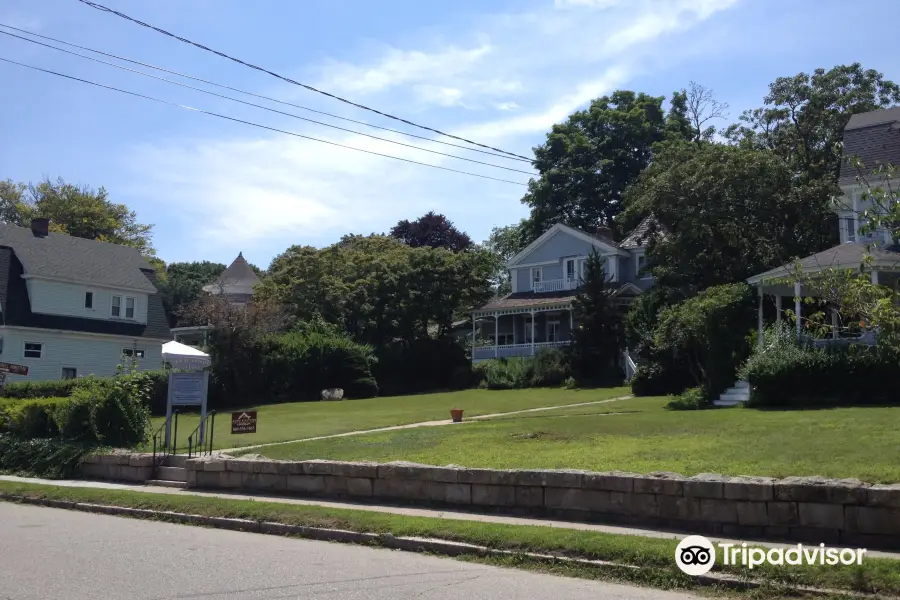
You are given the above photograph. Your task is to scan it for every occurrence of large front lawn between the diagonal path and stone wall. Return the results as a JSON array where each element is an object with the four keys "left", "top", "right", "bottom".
[{"left": 255, "top": 398, "right": 900, "bottom": 482}]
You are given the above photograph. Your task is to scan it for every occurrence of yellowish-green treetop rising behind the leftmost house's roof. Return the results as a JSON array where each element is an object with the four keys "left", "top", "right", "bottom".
[{"left": 0, "top": 177, "right": 155, "bottom": 256}]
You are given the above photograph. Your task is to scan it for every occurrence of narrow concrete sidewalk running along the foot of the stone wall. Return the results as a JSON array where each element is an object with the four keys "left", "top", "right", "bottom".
[{"left": 0, "top": 475, "right": 900, "bottom": 560}]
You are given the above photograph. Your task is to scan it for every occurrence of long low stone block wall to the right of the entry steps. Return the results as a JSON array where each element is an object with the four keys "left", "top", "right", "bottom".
[{"left": 181, "top": 458, "right": 900, "bottom": 548}]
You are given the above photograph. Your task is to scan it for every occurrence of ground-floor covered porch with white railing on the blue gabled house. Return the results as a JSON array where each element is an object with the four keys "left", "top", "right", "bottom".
[{"left": 472, "top": 301, "right": 574, "bottom": 362}]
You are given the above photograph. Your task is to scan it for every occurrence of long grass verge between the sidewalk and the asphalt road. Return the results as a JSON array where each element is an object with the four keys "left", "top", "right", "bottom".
[{"left": 0, "top": 481, "right": 900, "bottom": 597}]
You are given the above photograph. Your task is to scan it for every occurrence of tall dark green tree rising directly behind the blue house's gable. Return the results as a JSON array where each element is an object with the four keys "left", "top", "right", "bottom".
[{"left": 522, "top": 91, "right": 666, "bottom": 242}]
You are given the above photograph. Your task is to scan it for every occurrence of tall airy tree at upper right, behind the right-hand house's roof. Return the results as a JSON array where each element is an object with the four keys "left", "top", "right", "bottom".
[{"left": 726, "top": 63, "right": 900, "bottom": 184}]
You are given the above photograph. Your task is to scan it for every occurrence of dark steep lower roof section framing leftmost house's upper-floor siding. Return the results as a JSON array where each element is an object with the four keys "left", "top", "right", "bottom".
[{"left": 0, "top": 247, "right": 172, "bottom": 340}]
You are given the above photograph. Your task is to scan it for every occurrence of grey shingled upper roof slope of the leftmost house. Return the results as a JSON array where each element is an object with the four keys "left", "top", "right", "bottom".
[{"left": 0, "top": 224, "right": 156, "bottom": 293}]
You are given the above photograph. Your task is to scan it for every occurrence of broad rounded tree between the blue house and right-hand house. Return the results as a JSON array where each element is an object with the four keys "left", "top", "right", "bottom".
[{"left": 627, "top": 141, "right": 837, "bottom": 297}]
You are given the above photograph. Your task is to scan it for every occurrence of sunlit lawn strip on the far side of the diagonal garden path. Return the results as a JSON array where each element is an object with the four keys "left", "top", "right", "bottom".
[{"left": 153, "top": 388, "right": 631, "bottom": 451}]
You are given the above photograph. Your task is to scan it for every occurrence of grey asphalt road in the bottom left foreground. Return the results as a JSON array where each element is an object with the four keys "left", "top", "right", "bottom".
[{"left": 0, "top": 503, "right": 691, "bottom": 600}]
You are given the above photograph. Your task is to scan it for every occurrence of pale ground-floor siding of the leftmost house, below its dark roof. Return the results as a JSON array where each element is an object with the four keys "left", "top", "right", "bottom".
[{"left": 0, "top": 327, "right": 163, "bottom": 381}]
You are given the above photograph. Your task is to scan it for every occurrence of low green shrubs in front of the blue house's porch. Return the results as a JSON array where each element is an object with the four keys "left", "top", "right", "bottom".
[{"left": 475, "top": 348, "right": 569, "bottom": 390}]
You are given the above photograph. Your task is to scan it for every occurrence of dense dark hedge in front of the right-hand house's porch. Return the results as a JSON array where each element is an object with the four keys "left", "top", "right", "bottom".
[{"left": 741, "top": 331, "right": 900, "bottom": 408}]
